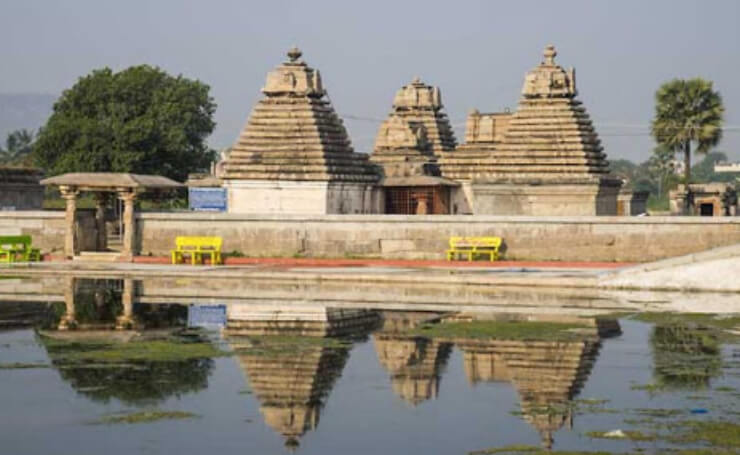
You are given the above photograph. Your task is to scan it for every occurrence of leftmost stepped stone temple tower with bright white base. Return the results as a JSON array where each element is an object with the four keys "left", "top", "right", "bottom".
[{"left": 220, "top": 48, "right": 380, "bottom": 214}]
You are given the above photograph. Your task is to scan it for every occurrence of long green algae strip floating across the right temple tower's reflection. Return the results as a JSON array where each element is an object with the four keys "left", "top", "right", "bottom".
[{"left": 409, "top": 321, "right": 588, "bottom": 341}]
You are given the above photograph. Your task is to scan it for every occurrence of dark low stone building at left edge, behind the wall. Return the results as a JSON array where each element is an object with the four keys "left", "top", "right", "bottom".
[{"left": 0, "top": 167, "right": 44, "bottom": 210}]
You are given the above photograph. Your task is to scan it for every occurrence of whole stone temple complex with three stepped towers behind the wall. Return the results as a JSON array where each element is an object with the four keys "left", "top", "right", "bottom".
[{"left": 214, "top": 45, "right": 641, "bottom": 216}]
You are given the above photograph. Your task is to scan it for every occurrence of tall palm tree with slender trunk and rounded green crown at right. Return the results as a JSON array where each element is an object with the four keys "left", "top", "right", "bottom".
[{"left": 652, "top": 78, "right": 725, "bottom": 212}]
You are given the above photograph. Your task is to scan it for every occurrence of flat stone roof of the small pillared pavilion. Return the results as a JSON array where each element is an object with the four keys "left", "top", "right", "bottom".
[{"left": 40, "top": 172, "right": 184, "bottom": 191}]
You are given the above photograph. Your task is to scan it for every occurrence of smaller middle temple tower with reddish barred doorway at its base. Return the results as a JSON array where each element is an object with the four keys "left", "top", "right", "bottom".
[{"left": 370, "top": 77, "right": 460, "bottom": 215}]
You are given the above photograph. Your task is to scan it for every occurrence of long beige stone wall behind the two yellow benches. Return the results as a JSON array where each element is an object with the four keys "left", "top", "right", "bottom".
[{"left": 137, "top": 213, "right": 740, "bottom": 262}]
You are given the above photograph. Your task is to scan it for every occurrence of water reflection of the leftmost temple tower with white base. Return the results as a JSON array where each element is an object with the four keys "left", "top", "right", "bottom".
[{"left": 224, "top": 305, "right": 377, "bottom": 447}]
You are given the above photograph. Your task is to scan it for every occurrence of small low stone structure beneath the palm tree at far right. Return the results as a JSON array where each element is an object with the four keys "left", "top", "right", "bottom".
[{"left": 668, "top": 182, "right": 738, "bottom": 216}]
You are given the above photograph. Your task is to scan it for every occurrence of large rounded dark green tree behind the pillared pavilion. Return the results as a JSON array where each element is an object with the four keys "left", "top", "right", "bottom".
[{"left": 33, "top": 65, "right": 216, "bottom": 180}]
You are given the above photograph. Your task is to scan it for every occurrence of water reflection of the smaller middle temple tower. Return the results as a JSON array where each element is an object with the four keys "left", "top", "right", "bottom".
[{"left": 373, "top": 311, "right": 452, "bottom": 406}]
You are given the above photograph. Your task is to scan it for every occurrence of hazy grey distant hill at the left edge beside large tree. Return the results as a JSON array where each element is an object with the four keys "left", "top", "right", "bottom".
[{"left": 0, "top": 93, "right": 57, "bottom": 142}]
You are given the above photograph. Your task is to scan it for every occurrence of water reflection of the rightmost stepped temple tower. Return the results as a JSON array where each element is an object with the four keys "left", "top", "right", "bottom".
[{"left": 454, "top": 320, "right": 619, "bottom": 449}]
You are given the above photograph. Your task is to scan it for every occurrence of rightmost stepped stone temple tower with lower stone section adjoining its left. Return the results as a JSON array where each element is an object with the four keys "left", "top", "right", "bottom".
[{"left": 440, "top": 45, "right": 621, "bottom": 215}]
